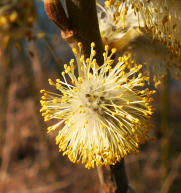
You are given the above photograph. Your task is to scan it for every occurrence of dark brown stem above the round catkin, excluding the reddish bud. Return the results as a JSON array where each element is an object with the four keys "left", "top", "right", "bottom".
[{"left": 66, "top": 0, "right": 103, "bottom": 62}]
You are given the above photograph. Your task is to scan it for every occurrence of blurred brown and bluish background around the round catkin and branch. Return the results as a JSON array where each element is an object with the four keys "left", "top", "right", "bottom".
[{"left": 0, "top": 0, "right": 181, "bottom": 193}]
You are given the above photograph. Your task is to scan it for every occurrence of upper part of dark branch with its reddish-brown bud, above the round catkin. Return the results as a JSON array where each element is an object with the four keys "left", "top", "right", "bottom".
[{"left": 44, "top": 0, "right": 103, "bottom": 64}]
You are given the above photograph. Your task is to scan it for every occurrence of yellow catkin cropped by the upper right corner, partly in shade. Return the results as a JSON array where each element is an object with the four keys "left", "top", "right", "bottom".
[{"left": 98, "top": 0, "right": 181, "bottom": 87}]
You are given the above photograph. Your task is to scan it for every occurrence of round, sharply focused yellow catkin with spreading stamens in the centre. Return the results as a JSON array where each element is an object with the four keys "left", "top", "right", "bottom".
[{"left": 40, "top": 43, "right": 155, "bottom": 168}]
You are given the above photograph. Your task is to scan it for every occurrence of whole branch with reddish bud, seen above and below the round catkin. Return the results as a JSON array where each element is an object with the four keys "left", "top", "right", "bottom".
[{"left": 44, "top": 0, "right": 128, "bottom": 193}]
